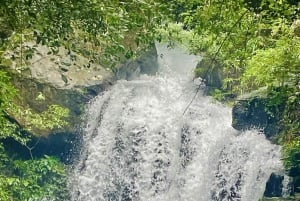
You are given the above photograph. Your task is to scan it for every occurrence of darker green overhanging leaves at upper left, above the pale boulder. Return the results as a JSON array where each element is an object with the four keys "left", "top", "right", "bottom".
[{"left": 0, "top": 0, "right": 168, "bottom": 65}]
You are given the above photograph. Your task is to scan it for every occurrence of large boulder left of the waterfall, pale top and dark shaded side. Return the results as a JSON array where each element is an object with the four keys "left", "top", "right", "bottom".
[{"left": 8, "top": 44, "right": 158, "bottom": 160}]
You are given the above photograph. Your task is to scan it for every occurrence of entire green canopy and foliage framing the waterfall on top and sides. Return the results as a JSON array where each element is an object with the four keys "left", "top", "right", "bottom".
[{"left": 0, "top": 0, "right": 300, "bottom": 200}]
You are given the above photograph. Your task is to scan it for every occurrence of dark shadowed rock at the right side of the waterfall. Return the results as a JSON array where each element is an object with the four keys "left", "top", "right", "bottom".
[{"left": 232, "top": 89, "right": 284, "bottom": 142}]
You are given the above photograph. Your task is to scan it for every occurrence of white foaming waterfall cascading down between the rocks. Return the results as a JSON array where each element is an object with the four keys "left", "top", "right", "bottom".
[{"left": 70, "top": 45, "right": 281, "bottom": 201}]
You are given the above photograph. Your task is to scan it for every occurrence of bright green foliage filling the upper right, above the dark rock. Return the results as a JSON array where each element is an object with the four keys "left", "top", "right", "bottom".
[{"left": 163, "top": 0, "right": 299, "bottom": 93}]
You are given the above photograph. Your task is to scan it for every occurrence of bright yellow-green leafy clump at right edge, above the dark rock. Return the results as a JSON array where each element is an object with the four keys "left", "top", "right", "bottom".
[{"left": 241, "top": 36, "right": 300, "bottom": 89}]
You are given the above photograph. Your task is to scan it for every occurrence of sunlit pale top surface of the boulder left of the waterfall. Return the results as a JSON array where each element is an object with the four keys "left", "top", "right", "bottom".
[{"left": 6, "top": 42, "right": 114, "bottom": 89}]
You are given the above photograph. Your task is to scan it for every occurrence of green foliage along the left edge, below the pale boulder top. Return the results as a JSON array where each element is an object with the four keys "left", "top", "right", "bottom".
[{"left": 0, "top": 71, "right": 68, "bottom": 201}]
